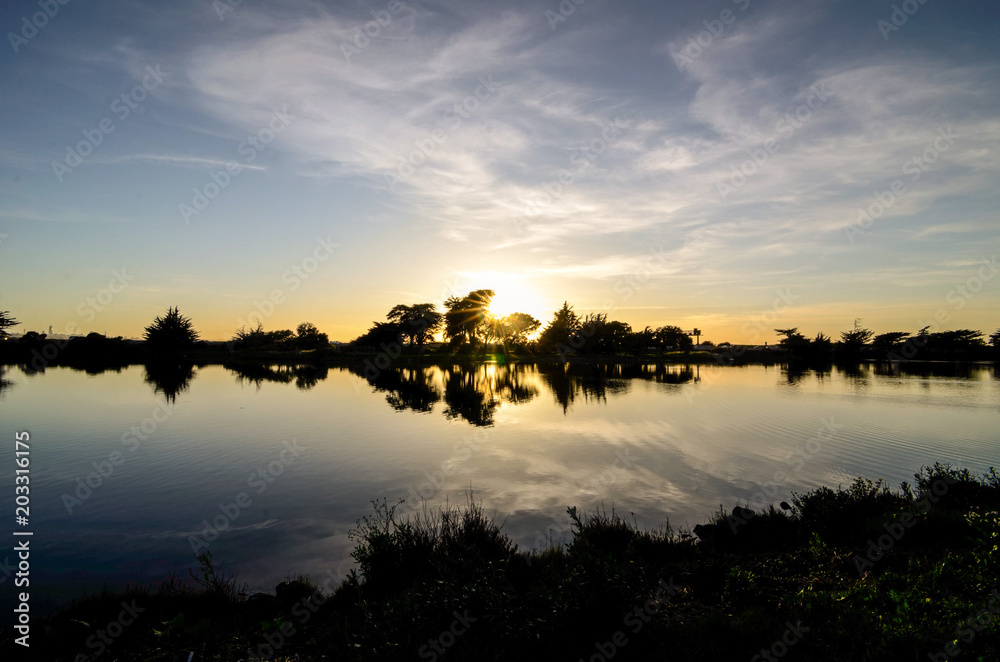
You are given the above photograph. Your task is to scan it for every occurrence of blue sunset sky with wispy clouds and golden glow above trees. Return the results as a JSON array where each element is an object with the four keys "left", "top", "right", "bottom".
[{"left": 0, "top": 0, "right": 1000, "bottom": 344}]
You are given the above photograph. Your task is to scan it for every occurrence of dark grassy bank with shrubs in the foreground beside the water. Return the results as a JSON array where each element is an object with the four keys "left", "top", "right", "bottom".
[{"left": 5, "top": 465, "right": 1000, "bottom": 662}]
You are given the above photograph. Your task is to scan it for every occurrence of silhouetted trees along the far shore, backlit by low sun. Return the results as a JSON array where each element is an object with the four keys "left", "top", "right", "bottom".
[{"left": 0, "top": 306, "right": 1000, "bottom": 360}]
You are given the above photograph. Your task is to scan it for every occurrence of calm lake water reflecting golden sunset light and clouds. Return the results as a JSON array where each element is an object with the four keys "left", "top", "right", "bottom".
[{"left": 0, "top": 365, "right": 1000, "bottom": 606}]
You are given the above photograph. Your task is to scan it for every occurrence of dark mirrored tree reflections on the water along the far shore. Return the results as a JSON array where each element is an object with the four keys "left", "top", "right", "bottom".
[{"left": 70, "top": 362, "right": 1000, "bottom": 427}]
